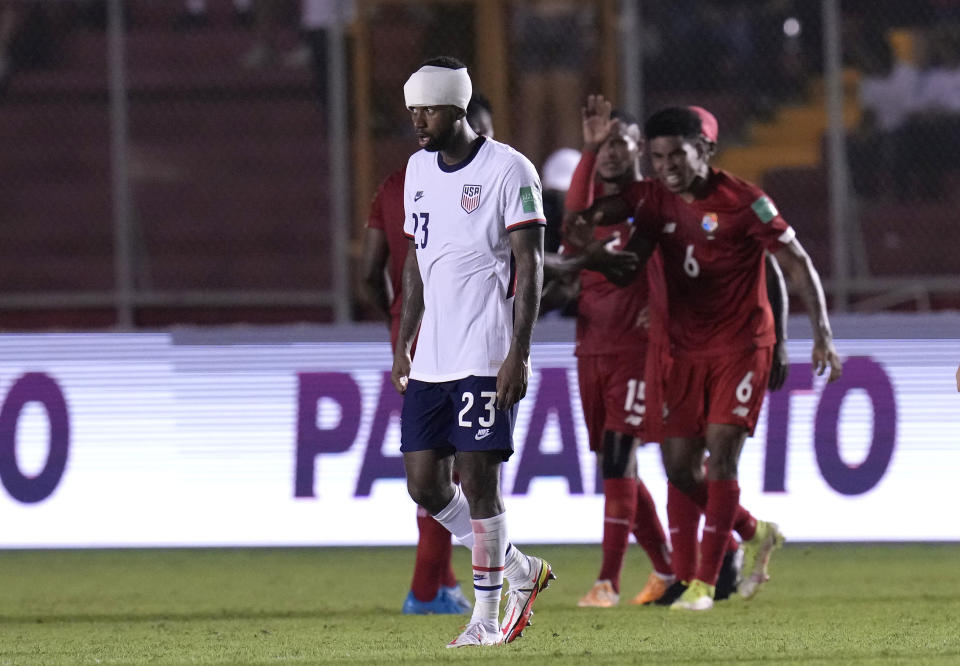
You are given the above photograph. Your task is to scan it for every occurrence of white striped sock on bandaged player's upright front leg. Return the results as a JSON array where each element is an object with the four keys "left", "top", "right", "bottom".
[{"left": 470, "top": 513, "right": 507, "bottom": 631}]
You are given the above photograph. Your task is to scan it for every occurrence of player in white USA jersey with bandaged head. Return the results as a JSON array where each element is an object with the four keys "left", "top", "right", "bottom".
[{"left": 392, "top": 57, "right": 555, "bottom": 647}]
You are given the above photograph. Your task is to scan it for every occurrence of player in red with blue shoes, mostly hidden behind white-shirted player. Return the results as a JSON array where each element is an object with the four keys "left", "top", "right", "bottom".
[{"left": 360, "top": 93, "right": 493, "bottom": 615}]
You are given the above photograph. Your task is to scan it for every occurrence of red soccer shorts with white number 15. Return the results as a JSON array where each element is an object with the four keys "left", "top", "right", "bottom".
[{"left": 577, "top": 350, "right": 646, "bottom": 451}]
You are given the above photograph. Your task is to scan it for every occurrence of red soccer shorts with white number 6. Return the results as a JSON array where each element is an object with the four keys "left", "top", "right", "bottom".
[{"left": 664, "top": 347, "right": 773, "bottom": 437}]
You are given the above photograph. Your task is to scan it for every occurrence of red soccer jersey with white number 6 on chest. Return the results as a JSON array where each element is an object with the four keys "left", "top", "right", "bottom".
[{"left": 628, "top": 169, "right": 795, "bottom": 355}]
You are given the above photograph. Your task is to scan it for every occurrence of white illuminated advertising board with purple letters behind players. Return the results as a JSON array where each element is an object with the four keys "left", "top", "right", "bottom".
[{"left": 0, "top": 315, "right": 960, "bottom": 548}]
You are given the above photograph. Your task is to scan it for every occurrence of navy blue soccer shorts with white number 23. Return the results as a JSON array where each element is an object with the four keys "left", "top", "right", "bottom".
[{"left": 400, "top": 375, "right": 517, "bottom": 460}]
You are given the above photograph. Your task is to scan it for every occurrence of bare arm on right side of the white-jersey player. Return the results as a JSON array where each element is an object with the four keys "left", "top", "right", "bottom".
[{"left": 497, "top": 225, "right": 543, "bottom": 410}]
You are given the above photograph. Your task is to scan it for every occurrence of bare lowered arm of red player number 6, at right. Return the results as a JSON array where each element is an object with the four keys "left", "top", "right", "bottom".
[{"left": 774, "top": 238, "right": 843, "bottom": 382}]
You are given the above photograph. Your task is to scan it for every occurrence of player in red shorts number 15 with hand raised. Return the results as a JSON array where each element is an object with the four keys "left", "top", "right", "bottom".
[{"left": 564, "top": 95, "right": 674, "bottom": 608}]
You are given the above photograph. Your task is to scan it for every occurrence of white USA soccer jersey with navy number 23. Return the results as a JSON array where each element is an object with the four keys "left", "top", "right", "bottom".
[{"left": 403, "top": 139, "right": 546, "bottom": 382}]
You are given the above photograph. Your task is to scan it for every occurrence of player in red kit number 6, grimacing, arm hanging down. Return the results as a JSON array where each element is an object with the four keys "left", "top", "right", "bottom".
[{"left": 612, "top": 107, "right": 841, "bottom": 610}]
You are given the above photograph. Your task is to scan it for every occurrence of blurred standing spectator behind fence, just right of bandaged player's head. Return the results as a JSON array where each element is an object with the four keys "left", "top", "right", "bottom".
[{"left": 512, "top": 0, "right": 593, "bottom": 171}]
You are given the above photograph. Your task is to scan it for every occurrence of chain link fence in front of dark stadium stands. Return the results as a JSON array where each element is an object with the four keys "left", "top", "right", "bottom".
[{"left": 0, "top": 0, "right": 960, "bottom": 328}]
